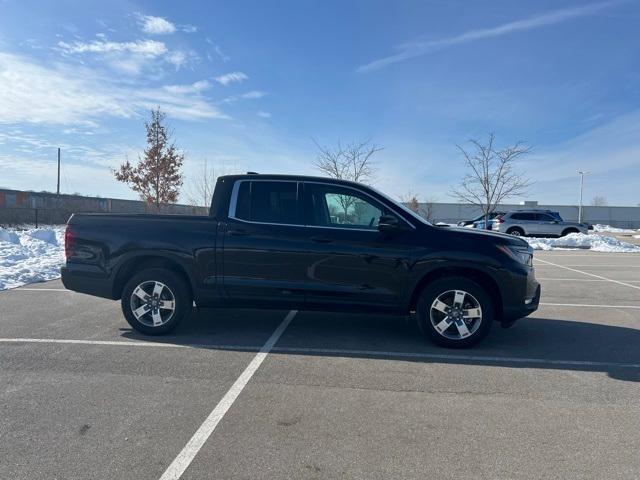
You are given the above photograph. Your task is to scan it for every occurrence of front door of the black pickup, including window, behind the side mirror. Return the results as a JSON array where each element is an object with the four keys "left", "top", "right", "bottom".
[{"left": 303, "top": 182, "right": 415, "bottom": 309}]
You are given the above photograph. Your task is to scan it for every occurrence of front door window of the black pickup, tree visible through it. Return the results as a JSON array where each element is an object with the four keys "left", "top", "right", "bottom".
[{"left": 305, "top": 184, "right": 387, "bottom": 230}]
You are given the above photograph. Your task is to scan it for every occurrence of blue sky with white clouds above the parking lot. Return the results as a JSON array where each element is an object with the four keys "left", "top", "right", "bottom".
[{"left": 0, "top": 0, "right": 640, "bottom": 205}]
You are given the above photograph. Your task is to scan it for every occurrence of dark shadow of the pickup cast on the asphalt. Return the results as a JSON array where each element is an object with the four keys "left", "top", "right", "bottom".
[{"left": 122, "top": 309, "right": 640, "bottom": 382}]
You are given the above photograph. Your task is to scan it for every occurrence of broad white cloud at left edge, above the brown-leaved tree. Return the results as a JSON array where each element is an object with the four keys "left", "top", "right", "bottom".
[{"left": 0, "top": 53, "right": 228, "bottom": 126}]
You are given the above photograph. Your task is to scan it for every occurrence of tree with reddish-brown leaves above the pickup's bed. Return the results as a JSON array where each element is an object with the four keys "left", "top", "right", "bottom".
[{"left": 113, "top": 107, "right": 184, "bottom": 212}]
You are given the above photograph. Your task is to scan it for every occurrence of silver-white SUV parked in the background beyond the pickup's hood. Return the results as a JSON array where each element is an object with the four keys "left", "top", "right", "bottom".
[{"left": 493, "top": 210, "right": 588, "bottom": 237}]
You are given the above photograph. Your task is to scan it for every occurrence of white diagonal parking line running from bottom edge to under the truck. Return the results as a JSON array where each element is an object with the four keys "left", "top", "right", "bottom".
[{"left": 160, "top": 310, "right": 298, "bottom": 480}]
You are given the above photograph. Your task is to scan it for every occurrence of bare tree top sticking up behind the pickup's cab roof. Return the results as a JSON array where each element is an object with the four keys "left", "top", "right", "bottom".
[{"left": 314, "top": 140, "right": 383, "bottom": 183}]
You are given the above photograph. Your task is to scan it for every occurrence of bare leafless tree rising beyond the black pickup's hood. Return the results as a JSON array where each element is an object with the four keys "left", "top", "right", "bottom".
[{"left": 452, "top": 133, "right": 531, "bottom": 225}]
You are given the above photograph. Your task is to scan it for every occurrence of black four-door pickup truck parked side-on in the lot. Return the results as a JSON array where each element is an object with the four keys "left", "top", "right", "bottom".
[{"left": 62, "top": 174, "right": 540, "bottom": 347}]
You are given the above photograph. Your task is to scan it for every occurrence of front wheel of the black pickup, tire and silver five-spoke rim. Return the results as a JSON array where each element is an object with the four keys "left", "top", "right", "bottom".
[{"left": 417, "top": 277, "right": 495, "bottom": 348}]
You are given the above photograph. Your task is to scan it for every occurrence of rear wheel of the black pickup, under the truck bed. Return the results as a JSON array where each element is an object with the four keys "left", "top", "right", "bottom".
[{"left": 120, "top": 268, "right": 193, "bottom": 335}]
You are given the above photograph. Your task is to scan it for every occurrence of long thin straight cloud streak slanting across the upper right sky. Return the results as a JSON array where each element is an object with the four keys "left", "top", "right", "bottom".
[{"left": 357, "top": 0, "right": 622, "bottom": 72}]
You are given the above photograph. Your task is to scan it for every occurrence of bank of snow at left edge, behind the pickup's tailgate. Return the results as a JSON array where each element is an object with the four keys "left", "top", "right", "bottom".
[{"left": 0, "top": 226, "right": 65, "bottom": 290}]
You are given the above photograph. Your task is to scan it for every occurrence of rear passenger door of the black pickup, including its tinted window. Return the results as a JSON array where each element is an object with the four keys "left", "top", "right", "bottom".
[{"left": 222, "top": 179, "right": 307, "bottom": 308}]
